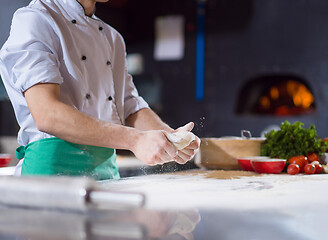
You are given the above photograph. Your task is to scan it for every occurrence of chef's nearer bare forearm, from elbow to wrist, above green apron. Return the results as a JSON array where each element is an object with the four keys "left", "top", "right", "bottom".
[{"left": 39, "top": 102, "right": 140, "bottom": 150}]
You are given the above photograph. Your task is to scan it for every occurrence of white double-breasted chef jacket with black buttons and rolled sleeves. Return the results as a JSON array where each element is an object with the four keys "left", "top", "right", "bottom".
[{"left": 0, "top": 0, "right": 148, "bottom": 146}]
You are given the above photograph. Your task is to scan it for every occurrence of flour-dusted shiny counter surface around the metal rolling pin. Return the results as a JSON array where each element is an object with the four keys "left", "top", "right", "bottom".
[{"left": 0, "top": 171, "right": 328, "bottom": 240}]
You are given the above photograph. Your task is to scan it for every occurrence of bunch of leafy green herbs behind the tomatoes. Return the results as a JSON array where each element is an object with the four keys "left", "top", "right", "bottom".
[{"left": 261, "top": 121, "right": 328, "bottom": 159}]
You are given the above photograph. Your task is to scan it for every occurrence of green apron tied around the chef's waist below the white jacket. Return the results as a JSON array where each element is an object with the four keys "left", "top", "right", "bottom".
[{"left": 16, "top": 138, "right": 120, "bottom": 180}]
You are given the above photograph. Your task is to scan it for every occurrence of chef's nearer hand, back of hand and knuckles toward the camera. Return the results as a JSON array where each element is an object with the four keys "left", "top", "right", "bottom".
[{"left": 132, "top": 130, "right": 177, "bottom": 166}]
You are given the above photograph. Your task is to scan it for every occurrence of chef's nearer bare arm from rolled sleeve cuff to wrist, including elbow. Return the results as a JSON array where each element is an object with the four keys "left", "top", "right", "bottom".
[{"left": 24, "top": 84, "right": 142, "bottom": 150}]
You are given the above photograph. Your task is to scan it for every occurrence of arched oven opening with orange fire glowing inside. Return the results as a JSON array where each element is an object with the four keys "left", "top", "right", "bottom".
[{"left": 236, "top": 75, "right": 316, "bottom": 116}]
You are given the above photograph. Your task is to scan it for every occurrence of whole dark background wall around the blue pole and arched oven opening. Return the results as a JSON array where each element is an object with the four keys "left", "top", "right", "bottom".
[{"left": 97, "top": 0, "right": 328, "bottom": 137}]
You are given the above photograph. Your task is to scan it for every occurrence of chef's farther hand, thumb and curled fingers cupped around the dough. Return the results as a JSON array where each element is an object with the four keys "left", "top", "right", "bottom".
[{"left": 173, "top": 122, "right": 200, "bottom": 164}]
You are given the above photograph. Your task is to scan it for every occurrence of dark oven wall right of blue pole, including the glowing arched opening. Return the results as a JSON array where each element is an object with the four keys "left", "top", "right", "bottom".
[{"left": 184, "top": 0, "right": 328, "bottom": 137}]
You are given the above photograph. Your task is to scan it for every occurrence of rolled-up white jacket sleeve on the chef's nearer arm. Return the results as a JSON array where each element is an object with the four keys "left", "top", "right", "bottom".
[{"left": 1, "top": 7, "right": 63, "bottom": 92}]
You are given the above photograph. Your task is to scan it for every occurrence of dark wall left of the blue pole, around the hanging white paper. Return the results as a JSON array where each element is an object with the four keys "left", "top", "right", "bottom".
[{"left": 96, "top": 0, "right": 206, "bottom": 135}]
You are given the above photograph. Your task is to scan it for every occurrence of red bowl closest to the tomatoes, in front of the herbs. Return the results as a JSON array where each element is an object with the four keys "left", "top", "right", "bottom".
[{"left": 252, "top": 158, "right": 286, "bottom": 174}]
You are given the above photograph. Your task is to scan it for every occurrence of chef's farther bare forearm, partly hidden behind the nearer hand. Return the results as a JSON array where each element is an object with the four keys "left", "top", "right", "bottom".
[{"left": 125, "top": 108, "right": 173, "bottom": 132}]
